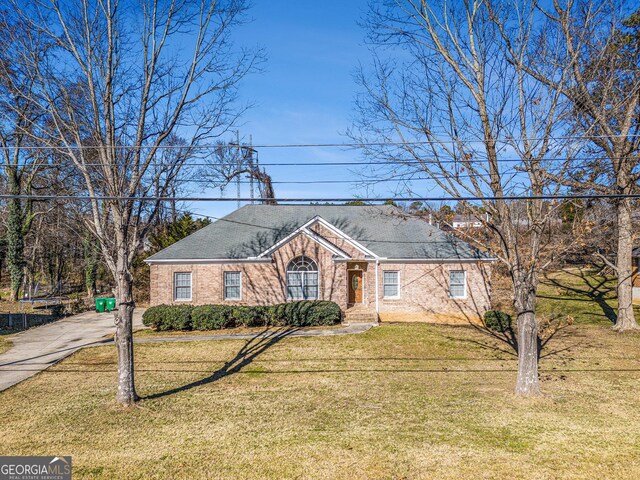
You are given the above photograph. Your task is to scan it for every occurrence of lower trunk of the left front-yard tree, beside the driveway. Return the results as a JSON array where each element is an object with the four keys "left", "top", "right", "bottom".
[{"left": 115, "top": 268, "right": 138, "bottom": 406}]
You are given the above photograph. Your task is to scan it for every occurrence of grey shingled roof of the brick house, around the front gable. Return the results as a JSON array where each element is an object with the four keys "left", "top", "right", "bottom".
[{"left": 147, "top": 205, "right": 488, "bottom": 262}]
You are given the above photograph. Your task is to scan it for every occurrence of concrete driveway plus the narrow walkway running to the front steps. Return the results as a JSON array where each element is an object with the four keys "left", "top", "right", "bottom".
[{"left": 0, "top": 308, "right": 372, "bottom": 392}]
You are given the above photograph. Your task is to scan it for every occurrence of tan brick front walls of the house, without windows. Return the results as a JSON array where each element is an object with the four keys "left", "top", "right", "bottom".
[{"left": 151, "top": 229, "right": 491, "bottom": 321}]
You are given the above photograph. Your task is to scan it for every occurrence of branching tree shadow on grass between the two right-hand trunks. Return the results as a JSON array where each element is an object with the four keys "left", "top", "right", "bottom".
[{"left": 538, "top": 269, "right": 618, "bottom": 324}]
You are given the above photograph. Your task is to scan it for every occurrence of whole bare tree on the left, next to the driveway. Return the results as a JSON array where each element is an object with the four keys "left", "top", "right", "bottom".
[{"left": 15, "top": 0, "right": 260, "bottom": 405}]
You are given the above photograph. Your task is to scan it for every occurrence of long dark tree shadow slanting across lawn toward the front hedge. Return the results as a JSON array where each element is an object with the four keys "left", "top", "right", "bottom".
[{"left": 143, "top": 327, "right": 300, "bottom": 400}]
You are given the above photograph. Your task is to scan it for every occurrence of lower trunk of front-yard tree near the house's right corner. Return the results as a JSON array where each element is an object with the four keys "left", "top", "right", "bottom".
[{"left": 514, "top": 279, "right": 541, "bottom": 397}]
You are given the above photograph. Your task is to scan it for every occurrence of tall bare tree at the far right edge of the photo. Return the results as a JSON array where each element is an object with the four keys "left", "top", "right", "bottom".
[{"left": 516, "top": 0, "right": 640, "bottom": 331}]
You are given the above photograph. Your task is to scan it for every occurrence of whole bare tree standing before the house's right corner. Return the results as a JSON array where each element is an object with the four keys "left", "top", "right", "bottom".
[{"left": 351, "top": 0, "right": 566, "bottom": 395}]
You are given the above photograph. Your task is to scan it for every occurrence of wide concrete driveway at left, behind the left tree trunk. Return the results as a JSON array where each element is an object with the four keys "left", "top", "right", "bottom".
[{"left": 0, "top": 308, "right": 144, "bottom": 391}]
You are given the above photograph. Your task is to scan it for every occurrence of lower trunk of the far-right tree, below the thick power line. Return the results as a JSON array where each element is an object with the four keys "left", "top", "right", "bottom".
[{"left": 613, "top": 198, "right": 638, "bottom": 332}]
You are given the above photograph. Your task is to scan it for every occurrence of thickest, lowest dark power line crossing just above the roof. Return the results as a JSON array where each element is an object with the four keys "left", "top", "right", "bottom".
[{"left": 0, "top": 193, "right": 640, "bottom": 203}]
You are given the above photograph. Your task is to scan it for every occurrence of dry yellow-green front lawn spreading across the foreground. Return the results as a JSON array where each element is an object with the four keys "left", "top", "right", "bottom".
[{"left": 0, "top": 268, "right": 640, "bottom": 479}]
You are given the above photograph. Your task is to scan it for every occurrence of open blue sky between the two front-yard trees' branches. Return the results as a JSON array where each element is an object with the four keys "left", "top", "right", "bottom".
[{"left": 194, "top": 0, "right": 376, "bottom": 216}]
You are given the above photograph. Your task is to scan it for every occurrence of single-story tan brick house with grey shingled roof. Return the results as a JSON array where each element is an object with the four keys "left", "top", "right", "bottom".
[{"left": 146, "top": 205, "right": 493, "bottom": 321}]
